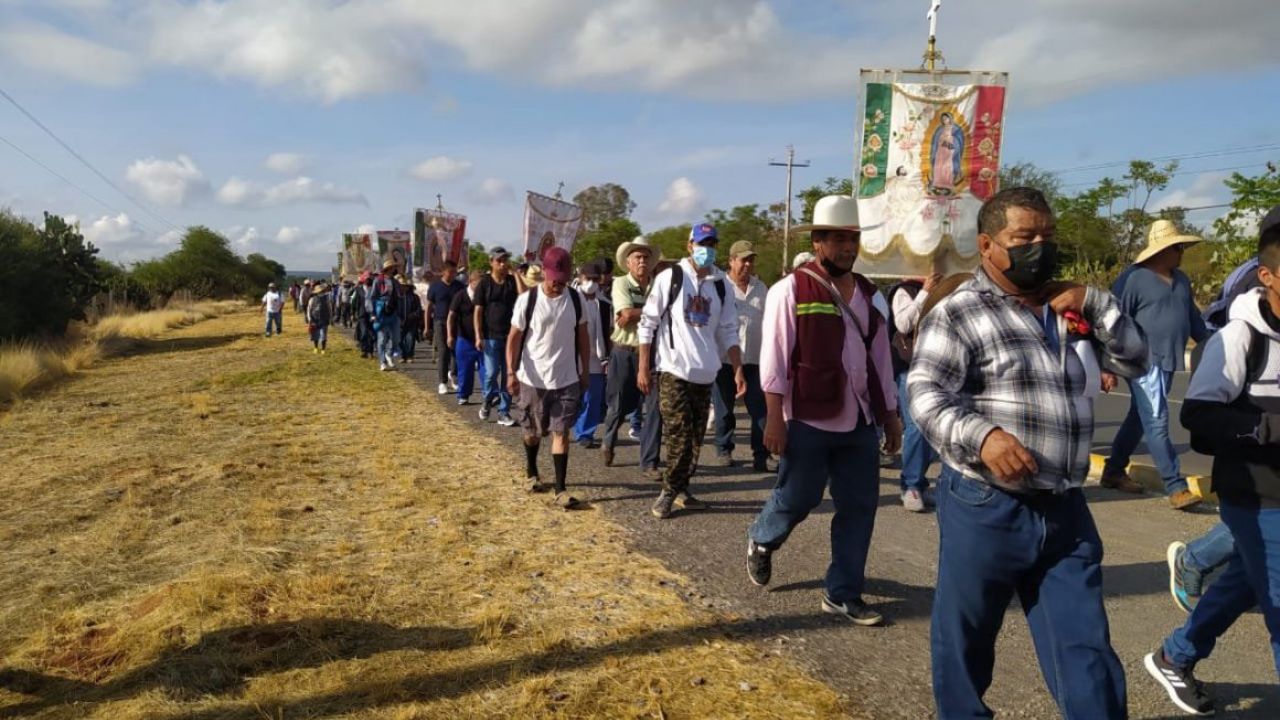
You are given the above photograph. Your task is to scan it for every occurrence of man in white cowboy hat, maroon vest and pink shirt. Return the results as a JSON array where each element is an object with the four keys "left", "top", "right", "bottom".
[{"left": 746, "top": 195, "right": 902, "bottom": 625}]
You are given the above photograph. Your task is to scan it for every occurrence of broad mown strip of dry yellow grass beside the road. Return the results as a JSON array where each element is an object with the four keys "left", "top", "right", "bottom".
[{"left": 0, "top": 307, "right": 844, "bottom": 719}]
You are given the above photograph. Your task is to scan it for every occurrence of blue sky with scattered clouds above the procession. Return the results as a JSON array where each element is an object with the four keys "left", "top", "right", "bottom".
[{"left": 0, "top": 0, "right": 1280, "bottom": 269}]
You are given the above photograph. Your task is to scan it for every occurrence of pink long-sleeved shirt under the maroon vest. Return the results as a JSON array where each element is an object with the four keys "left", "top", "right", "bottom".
[{"left": 760, "top": 275, "right": 897, "bottom": 433}]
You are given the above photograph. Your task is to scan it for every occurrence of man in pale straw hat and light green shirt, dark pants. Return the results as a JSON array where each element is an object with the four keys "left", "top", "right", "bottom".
[{"left": 602, "top": 237, "right": 662, "bottom": 471}]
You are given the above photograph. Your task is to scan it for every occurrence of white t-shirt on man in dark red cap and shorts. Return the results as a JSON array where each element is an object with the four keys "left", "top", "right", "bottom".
[{"left": 511, "top": 287, "right": 586, "bottom": 389}]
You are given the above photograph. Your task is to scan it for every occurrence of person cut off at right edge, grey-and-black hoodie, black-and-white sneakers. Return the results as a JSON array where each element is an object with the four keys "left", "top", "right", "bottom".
[{"left": 1143, "top": 209, "right": 1280, "bottom": 715}]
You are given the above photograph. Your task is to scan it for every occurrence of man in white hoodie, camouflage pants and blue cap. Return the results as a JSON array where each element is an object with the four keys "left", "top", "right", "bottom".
[{"left": 636, "top": 223, "right": 746, "bottom": 519}]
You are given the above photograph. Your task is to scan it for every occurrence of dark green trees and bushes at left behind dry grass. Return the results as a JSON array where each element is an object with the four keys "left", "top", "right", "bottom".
[{"left": 0, "top": 210, "right": 284, "bottom": 340}]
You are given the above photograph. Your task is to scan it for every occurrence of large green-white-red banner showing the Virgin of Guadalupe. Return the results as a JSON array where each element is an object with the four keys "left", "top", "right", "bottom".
[{"left": 855, "top": 70, "right": 1005, "bottom": 275}]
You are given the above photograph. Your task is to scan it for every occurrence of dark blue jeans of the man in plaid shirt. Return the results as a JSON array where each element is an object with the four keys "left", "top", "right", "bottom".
[{"left": 929, "top": 468, "right": 1126, "bottom": 720}]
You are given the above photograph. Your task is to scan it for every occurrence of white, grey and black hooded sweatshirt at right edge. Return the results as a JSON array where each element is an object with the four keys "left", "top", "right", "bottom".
[{"left": 1181, "top": 288, "right": 1280, "bottom": 507}]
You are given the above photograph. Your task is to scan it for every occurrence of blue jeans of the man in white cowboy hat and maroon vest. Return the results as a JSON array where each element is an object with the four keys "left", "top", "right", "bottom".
[{"left": 747, "top": 420, "right": 879, "bottom": 603}]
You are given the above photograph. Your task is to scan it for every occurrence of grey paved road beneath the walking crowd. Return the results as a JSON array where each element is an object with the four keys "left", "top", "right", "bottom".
[{"left": 394, "top": 348, "right": 1280, "bottom": 720}]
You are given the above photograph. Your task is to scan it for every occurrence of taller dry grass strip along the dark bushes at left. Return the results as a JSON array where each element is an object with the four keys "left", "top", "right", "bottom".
[{"left": 0, "top": 301, "right": 244, "bottom": 404}]
